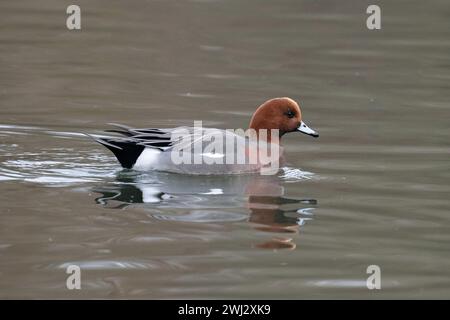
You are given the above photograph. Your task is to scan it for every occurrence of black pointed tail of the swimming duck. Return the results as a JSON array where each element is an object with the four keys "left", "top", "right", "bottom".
[{"left": 90, "top": 136, "right": 145, "bottom": 169}]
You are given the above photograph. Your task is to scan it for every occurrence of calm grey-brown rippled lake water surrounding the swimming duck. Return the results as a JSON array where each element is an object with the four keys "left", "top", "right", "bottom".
[{"left": 0, "top": 0, "right": 450, "bottom": 299}]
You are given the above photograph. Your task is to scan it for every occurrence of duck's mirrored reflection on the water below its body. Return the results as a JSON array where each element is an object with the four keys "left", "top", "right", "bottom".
[{"left": 93, "top": 171, "right": 317, "bottom": 249}]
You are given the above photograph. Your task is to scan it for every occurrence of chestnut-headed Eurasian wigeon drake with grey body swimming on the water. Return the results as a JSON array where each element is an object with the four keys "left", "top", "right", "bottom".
[{"left": 93, "top": 98, "right": 319, "bottom": 174}]
